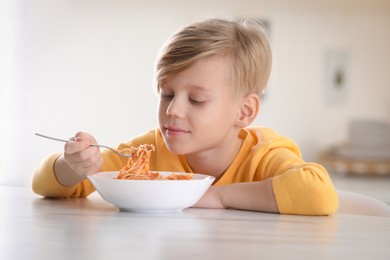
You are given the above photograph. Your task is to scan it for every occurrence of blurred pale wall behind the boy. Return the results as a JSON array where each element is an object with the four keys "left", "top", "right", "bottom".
[{"left": 0, "top": 0, "right": 390, "bottom": 198}]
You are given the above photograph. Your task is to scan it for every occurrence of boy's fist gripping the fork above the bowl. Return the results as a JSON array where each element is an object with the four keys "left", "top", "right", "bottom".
[{"left": 64, "top": 132, "right": 103, "bottom": 178}]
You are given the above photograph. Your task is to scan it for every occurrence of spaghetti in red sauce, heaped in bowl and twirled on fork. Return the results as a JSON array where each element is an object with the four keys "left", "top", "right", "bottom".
[{"left": 116, "top": 144, "right": 192, "bottom": 180}]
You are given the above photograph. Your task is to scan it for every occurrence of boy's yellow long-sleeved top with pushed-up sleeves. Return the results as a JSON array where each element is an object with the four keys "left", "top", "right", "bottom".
[{"left": 32, "top": 127, "right": 338, "bottom": 215}]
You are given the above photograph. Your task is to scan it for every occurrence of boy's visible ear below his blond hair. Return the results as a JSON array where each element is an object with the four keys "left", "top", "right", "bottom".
[{"left": 237, "top": 93, "right": 260, "bottom": 128}]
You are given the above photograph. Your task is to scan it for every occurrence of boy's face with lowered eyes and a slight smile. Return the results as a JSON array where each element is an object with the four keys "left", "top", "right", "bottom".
[{"left": 159, "top": 57, "right": 241, "bottom": 155}]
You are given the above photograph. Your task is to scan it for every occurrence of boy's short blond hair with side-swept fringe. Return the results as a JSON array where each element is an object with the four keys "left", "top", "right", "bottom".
[{"left": 155, "top": 18, "right": 272, "bottom": 95}]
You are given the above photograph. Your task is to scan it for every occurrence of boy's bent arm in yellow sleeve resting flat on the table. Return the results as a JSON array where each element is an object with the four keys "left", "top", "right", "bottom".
[{"left": 194, "top": 149, "right": 338, "bottom": 215}]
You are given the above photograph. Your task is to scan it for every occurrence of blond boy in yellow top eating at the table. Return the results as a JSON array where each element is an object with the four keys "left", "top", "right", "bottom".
[{"left": 32, "top": 19, "right": 338, "bottom": 215}]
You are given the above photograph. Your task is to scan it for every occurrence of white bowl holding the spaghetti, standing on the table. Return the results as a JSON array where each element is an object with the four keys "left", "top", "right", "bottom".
[{"left": 88, "top": 171, "right": 215, "bottom": 212}]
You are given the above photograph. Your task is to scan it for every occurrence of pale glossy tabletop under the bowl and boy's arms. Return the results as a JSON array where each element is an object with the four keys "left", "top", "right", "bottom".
[{"left": 0, "top": 186, "right": 390, "bottom": 260}]
